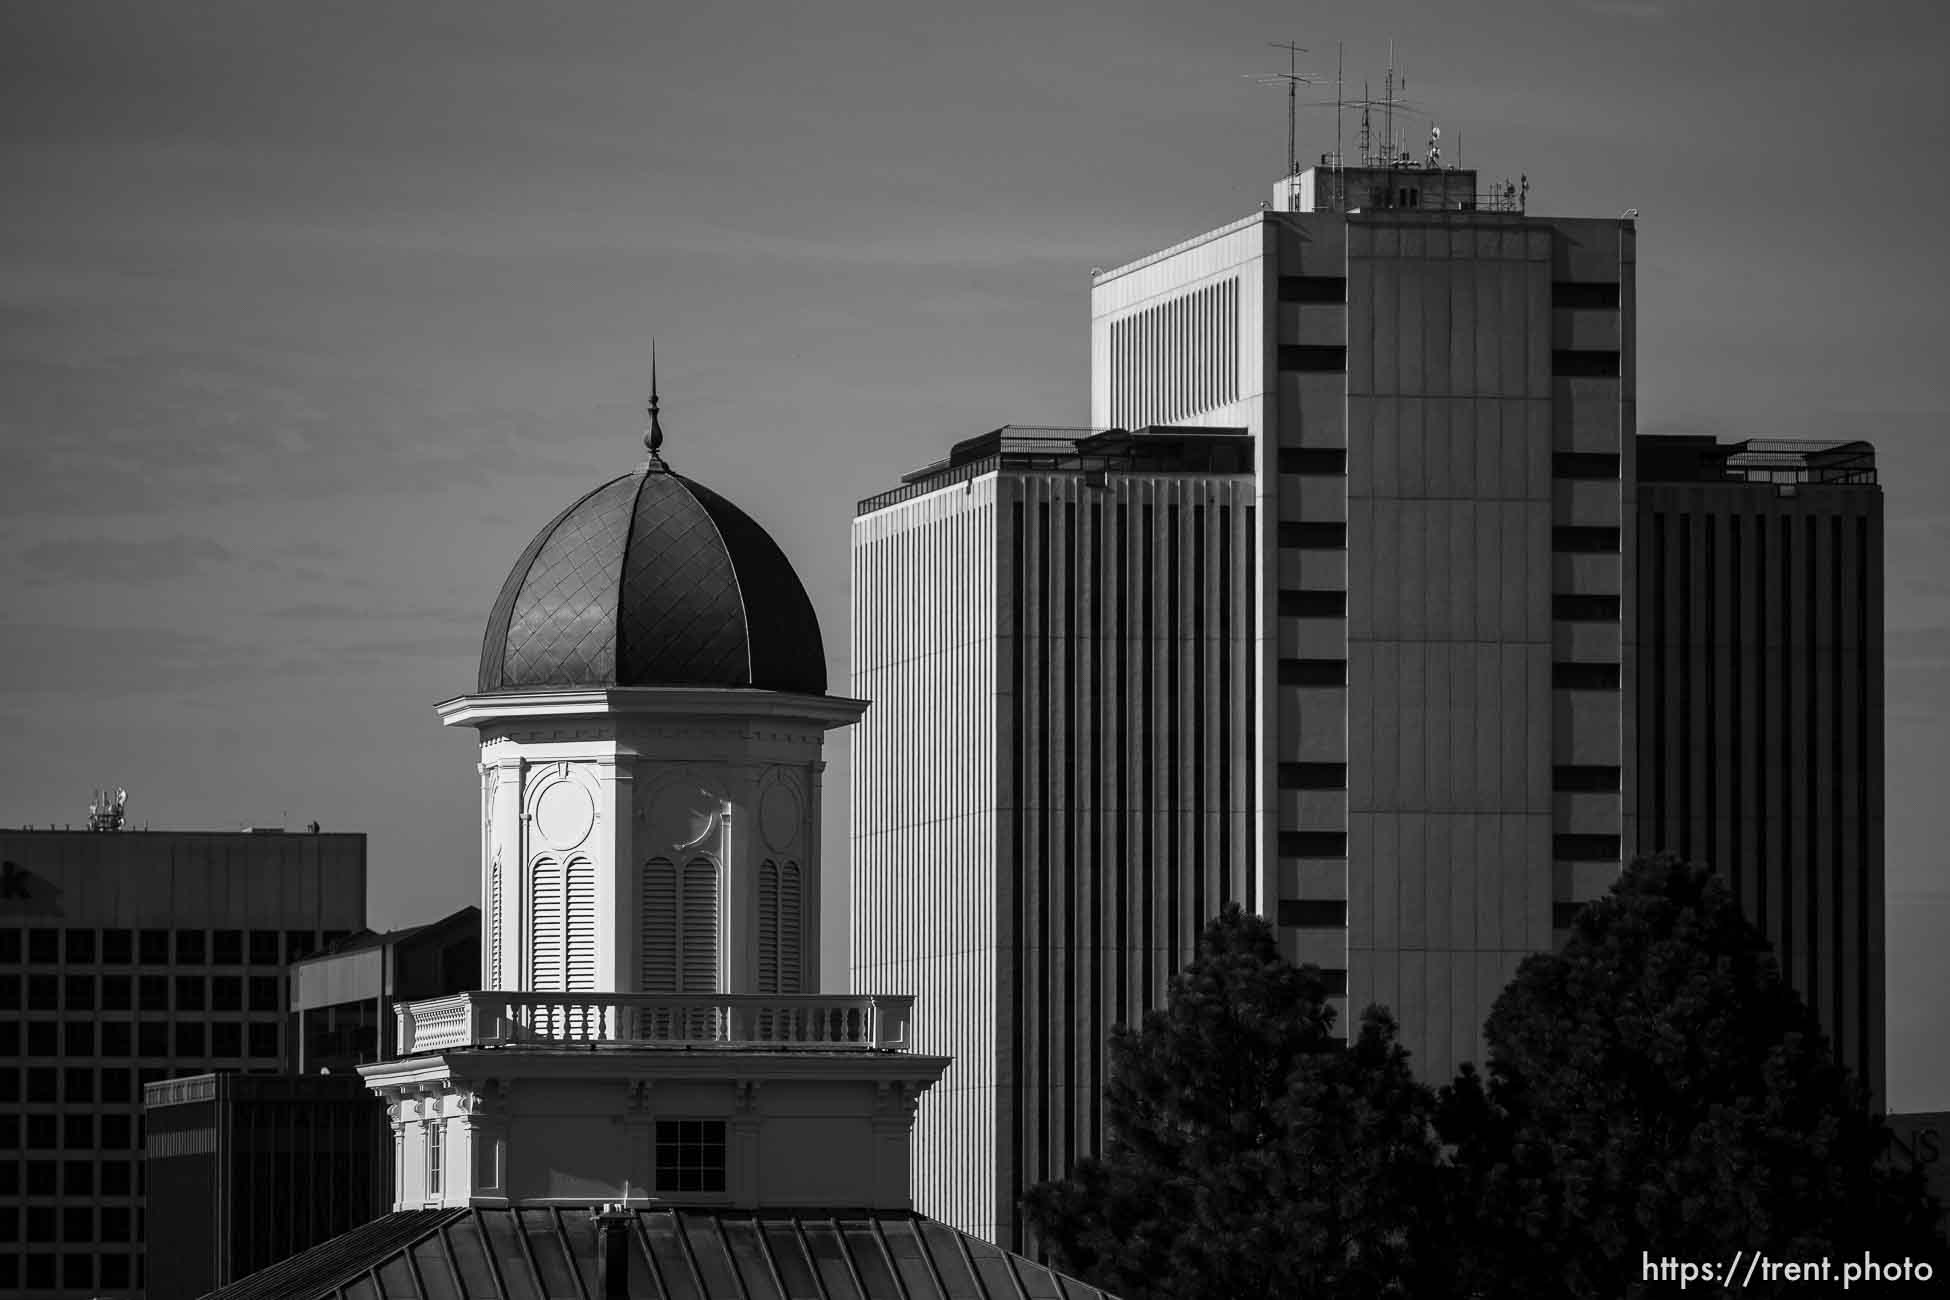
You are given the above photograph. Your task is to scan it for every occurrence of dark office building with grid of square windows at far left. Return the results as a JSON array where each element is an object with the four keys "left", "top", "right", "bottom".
[{"left": 0, "top": 826, "right": 367, "bottom": 1300}]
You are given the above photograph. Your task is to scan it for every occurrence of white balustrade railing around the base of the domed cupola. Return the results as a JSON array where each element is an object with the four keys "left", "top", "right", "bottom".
[{"left": 394, "top": 992, "right": 915, "bottom": 1056}]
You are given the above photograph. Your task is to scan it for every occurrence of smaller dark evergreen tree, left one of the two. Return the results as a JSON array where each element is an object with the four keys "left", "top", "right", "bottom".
[{"left": 1024, "top": 906, "right": 1437, "bottom": 1300}]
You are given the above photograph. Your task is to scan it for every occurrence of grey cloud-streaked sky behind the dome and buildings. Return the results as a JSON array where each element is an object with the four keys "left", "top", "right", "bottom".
[{"left": 0, "top": 0, "right": 1950, "bottom": 1109}]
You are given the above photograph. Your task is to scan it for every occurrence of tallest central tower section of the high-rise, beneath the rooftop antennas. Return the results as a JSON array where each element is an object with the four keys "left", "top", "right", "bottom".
[{"left": 1090, "top": 150, "right": 1634, "bottom": 1080}]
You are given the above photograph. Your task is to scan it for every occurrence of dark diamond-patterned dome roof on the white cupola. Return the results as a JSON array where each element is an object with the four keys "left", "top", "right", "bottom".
[{"left": 480, "top": 462, "right": 827, "bottom": 694}]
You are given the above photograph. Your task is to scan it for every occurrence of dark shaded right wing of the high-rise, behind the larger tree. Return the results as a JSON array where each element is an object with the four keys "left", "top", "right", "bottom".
[{"left": 1636, "top": 437, "right": 1886, "bottom": 1105}]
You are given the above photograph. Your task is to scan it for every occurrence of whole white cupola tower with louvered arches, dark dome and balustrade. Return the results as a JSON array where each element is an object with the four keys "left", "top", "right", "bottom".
[{"left": 361, "top": 388, "right": 948, "bottom": 1210}]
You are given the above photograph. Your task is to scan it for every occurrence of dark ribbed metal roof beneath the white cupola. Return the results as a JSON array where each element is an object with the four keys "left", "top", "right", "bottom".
[{"left": 205, "top": 1204, "right": 1112, "bottom": 1300}]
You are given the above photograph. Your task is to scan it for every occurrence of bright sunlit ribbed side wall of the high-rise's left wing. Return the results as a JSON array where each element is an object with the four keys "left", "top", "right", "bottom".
[{"left": 848, "top": 476, "right": 1016, "bottom": 1240}]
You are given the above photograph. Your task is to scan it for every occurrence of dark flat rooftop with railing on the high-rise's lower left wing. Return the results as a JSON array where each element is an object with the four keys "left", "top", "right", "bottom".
[{"left": 856, "top": 425, "right": 1252, "bottom": 515}]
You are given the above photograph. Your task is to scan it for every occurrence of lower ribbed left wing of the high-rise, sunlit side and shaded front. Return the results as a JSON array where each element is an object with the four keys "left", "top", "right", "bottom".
[{"left": 850, "top": 427, "right": 1258, "bottom": 1247}]
